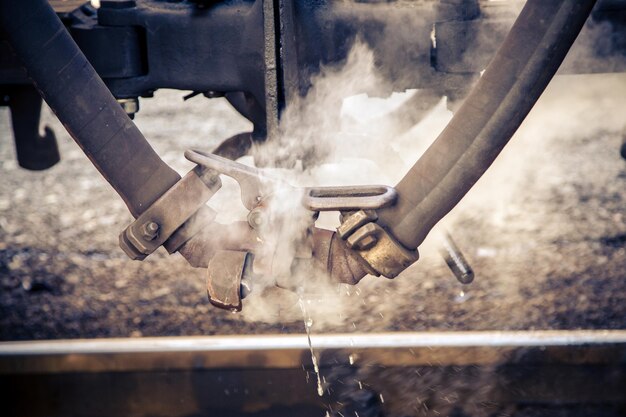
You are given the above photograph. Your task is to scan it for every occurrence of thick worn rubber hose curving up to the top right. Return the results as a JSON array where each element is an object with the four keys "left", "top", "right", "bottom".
[{"left": 379, "top": 0, "right": 595, "bottom": 249}]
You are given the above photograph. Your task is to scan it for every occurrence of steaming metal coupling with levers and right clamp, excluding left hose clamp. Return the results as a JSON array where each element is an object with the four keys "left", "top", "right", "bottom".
[{"left": 180, "top": 151, "right": 417, "bottom": 310}]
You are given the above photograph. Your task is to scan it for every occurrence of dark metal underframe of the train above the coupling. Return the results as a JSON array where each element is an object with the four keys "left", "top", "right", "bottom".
[{"left": 0, "top": 0, "right": 626, "bottom": 162}]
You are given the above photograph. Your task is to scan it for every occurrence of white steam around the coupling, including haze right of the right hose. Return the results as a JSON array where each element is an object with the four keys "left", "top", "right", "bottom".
[{"left": 204, "top": 5, "right": 623, "bottom": 331}]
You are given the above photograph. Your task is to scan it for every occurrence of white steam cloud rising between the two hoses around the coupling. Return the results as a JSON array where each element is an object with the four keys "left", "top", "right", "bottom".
[{"left": 229, "top": 40, "right": 451, "bottom": 331}]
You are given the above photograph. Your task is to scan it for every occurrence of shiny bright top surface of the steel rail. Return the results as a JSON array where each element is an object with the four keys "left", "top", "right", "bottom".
[{"left": 0, "top": 330, "right": 626, "bottom": 356}]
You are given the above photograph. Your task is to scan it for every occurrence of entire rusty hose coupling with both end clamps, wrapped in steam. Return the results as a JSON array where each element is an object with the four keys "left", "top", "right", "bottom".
[{"left": 120, "top": 150, "right": 473, "bottom": 311}]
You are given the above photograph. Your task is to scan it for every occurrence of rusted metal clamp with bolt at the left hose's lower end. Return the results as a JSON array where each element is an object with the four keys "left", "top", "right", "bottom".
[{"left": 120, "top": 166, "right": 222, "bottom": 260}]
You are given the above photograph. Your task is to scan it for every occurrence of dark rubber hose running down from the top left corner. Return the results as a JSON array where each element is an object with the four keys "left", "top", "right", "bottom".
[{"left": 0, "top": 0, "right": 180, "bottom": 217}]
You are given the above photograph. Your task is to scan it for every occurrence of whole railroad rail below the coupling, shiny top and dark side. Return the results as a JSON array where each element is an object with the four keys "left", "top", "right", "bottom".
[{"left": 0, "top": 330, "right": 626, "bottom": 417}]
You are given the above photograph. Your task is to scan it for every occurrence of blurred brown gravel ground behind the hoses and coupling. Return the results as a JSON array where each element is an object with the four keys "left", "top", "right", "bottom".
[{"left": 0, "top": 75, "right": 626, "bottom": 340}]
